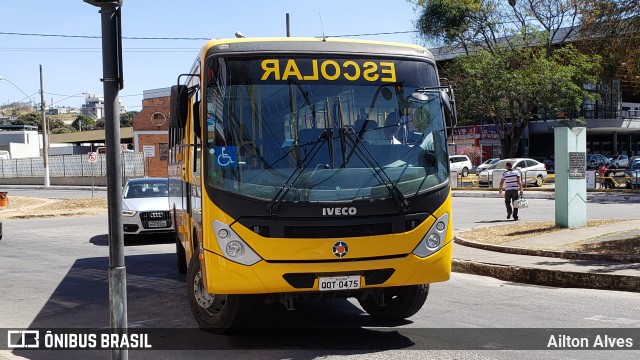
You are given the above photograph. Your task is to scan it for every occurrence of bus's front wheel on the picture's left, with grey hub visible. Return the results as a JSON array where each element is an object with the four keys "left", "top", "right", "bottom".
[{"left": 187, "top": 256, "right": 255, "bottom": 334}]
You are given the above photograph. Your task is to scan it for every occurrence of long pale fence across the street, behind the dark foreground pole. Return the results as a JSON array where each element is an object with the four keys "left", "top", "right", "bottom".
[{"left": 0, "top": 152, "right": 145, "bottom": 179}]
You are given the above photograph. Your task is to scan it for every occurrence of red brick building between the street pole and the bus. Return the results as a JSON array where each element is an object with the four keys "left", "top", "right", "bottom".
[{"left": 132, "top": 88, "right": 171, "bottom": 177}]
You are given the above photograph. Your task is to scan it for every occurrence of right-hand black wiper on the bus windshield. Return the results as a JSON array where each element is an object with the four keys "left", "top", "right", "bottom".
[{"left": 340, "top": 128, "right": 409, "bottom": 212}]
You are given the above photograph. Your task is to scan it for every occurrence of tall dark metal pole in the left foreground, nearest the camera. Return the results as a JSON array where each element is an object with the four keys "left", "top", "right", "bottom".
[{"left": 84, "top": 0, "right": 129, "bottom": 360}]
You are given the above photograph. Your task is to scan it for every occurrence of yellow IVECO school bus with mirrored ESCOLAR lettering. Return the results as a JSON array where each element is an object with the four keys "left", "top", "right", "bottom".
[{"left": 169, "top": 38, "right": 456, "bottom": 333}]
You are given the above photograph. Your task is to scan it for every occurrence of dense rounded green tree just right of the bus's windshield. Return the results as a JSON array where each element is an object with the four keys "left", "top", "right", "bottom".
[{"left": 448, "top": 46, "right": 599, "bottom": 157}]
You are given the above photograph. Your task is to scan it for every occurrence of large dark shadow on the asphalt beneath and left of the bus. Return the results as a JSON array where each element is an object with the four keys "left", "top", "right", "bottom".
[{"left": 14, "top": 250, "right": 424, "bottom": 359}]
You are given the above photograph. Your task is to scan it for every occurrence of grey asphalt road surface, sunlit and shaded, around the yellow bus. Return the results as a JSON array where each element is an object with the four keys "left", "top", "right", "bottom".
[{"left": 0, "top": 191, "right": 640, "bottom": 359}]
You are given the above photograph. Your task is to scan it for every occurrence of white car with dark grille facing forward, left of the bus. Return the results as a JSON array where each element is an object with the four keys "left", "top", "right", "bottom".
[{"left": 122, "top": 178, "right": 175, "bottom": 237}]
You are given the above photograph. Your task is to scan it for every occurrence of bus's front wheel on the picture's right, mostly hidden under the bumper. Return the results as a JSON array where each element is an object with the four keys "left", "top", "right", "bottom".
[{"left": 358, "top": 284, "right": 429, "bottom": 320}]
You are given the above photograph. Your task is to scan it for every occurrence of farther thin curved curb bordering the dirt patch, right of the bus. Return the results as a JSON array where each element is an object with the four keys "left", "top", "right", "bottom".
[{"left": 453, "top": 237, "right": 640, "bottom": 263}]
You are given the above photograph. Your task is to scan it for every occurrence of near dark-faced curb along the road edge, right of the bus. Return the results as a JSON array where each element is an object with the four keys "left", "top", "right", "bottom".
[{"left": 452, "top": 259, "right": 640, "bottom": 292}]
